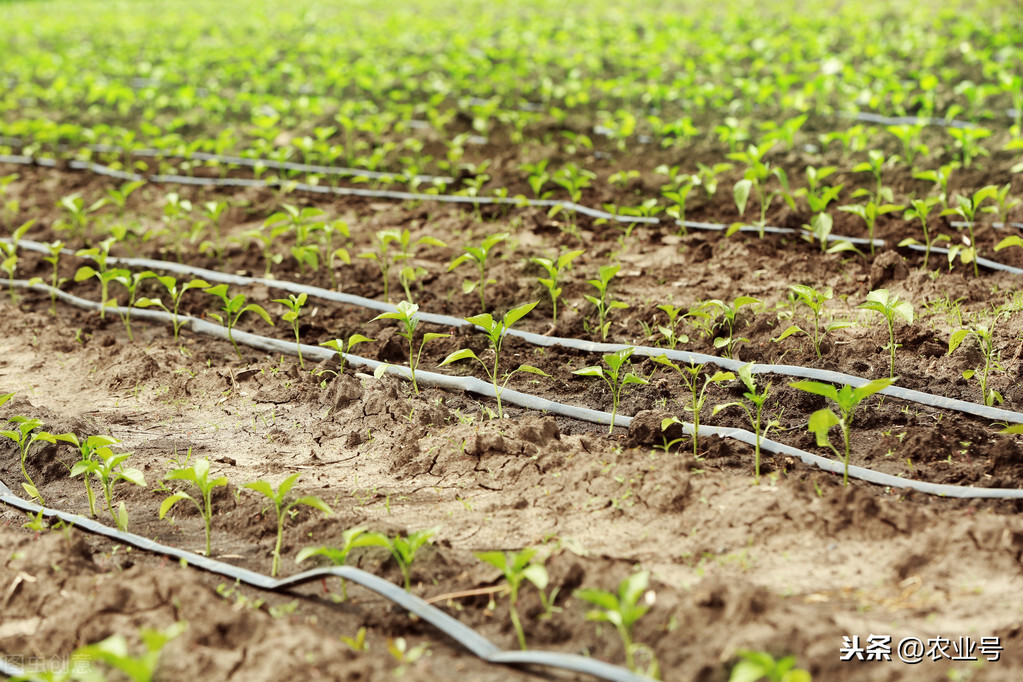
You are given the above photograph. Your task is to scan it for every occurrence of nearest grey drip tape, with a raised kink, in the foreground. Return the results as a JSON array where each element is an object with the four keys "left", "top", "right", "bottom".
[{"left": 0, "top": 481, "right": 650, "bottom": 682}]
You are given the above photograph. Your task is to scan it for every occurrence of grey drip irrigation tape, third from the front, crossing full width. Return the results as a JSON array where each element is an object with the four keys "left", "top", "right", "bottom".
[{"left": 7, "top": 235, "right": 1023, "bottom": 423}]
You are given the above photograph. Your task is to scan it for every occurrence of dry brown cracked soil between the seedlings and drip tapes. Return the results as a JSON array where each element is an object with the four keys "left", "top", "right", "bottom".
[{"left": 6, "top": 139, "right": 1023, "bottom": 681}]
